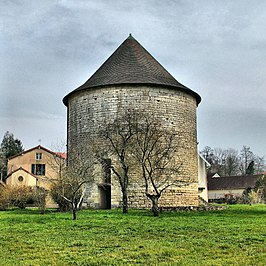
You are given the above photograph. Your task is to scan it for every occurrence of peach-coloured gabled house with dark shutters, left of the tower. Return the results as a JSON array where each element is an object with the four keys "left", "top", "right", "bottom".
[{"left": 6, "top": 145, "right": 66, "bottom": 204}]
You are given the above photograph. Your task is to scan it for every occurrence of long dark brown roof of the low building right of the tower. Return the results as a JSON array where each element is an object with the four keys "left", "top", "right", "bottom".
[{"left": 208, "top": 175, "right": 261, "bottom": 190}]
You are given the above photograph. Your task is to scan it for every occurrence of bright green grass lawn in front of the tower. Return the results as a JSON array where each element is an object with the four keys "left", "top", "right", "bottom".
[{"left": 0, "top": 205, "right": 266, "bottom": 265}]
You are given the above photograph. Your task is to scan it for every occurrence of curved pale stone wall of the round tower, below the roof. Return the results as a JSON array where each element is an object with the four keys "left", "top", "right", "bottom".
[{"left": 68, "top": 85, "right": 198, "bottom": 208}]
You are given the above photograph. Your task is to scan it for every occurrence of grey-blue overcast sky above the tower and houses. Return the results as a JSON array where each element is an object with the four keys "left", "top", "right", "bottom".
[{"left": 0, "top": 0, "right": 266, "bottom": 156}]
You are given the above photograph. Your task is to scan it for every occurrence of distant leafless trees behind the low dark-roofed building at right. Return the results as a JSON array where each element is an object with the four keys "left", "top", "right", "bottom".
[{"left": 200, "top": 146, "right": 265, "bottom": 176}]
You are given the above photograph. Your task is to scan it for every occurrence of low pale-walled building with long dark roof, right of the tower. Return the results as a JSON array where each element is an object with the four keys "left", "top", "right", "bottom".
[{"left": 207, "top": 175, "right": 261, "bottom": 201}]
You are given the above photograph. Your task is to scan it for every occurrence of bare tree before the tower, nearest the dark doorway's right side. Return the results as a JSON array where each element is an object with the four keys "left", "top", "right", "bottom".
[{"left": 97, "top": 110, "right": 136, "bottom": 213}]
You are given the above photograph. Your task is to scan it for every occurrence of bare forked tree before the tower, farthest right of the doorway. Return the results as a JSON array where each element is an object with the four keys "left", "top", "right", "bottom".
[{"left": 131, "top": 113, "right": 185, "bottom": 216}]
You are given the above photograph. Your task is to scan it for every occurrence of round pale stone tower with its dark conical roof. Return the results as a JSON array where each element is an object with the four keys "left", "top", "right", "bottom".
[{"left": 63, "top": 35, "right": 201, "bottom": 208}]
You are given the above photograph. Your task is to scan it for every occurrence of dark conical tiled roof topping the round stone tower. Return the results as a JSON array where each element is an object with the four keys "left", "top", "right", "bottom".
[{"left": 63, "top": 34, "right": 201, "bottom": 106}]
